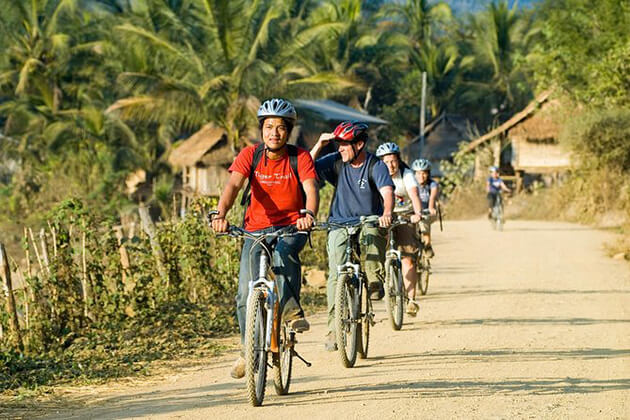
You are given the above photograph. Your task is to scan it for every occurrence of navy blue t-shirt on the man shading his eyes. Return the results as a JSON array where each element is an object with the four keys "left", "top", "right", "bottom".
[{"left": 315, "top": 152, "right": 394, "bottom": 223}]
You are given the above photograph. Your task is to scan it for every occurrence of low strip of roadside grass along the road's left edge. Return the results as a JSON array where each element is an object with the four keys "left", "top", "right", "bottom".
[{"left": 0, "top": 286, "right": 326, "bottom": 398}]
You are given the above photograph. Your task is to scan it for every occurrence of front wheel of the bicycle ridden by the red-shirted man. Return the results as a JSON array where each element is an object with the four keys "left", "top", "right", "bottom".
[{"left": 245, "top": 289, "right": 267, "bottom": 407}]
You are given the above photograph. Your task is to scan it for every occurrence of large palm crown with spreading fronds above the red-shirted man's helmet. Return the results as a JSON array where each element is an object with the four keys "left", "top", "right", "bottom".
[{"left": 108, "top": 0, "right": 358, "bottom": 147}]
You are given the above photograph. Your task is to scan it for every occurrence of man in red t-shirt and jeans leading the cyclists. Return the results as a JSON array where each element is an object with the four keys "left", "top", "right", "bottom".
[{"left": 212, "top": 99, "right": 319, "bottom": 379}]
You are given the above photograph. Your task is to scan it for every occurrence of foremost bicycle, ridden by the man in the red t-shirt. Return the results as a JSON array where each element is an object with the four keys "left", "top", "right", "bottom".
[{"left": 208, "top": 212, "right": 311, "bottom": 407}]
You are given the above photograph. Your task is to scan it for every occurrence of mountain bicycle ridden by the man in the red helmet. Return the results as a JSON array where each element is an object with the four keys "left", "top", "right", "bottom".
[{"left": 316, "top": 216, "right": 378, "bottom": 368}]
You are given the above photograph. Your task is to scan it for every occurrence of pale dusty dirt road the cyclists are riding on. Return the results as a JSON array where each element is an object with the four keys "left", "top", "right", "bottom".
[{"left": 33, "top": 220, "right": 630, "bottom": 420}]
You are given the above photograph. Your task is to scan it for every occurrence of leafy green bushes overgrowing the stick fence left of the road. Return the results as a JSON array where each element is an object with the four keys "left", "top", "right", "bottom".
[{"left": 0, "top": 200, "right": 240, "bottom": 391}]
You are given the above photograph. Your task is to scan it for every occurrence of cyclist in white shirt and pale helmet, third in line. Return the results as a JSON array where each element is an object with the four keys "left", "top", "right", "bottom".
[{"left": 376, "top": 142, "right": 422, "bottom": 316}]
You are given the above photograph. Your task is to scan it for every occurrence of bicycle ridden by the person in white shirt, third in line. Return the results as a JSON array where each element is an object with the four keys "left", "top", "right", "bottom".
[{"left": 385, "top": 216, "right": 410, "bottom": 331}]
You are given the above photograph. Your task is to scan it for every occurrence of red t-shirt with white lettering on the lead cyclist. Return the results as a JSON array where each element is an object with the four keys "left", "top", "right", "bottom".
[{"left": 228, "top": 145, "right": 317, "bottom": 231}]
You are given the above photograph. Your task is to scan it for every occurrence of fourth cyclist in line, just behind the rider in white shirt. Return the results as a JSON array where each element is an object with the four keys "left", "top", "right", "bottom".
[{"left": 411, "top": 159, "right": 440, "bottom": 258}]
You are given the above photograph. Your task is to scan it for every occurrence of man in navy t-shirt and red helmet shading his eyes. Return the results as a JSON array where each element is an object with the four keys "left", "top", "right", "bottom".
[{"left": 311, "top": 122, "right": 394, "bottom": 351}]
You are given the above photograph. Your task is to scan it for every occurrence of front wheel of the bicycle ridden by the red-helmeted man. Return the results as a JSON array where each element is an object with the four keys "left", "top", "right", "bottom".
[{"left": 335, "top": 275, "right": 359, "bottom": 368}]
